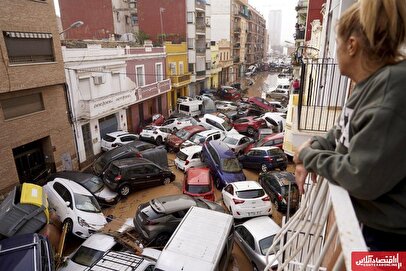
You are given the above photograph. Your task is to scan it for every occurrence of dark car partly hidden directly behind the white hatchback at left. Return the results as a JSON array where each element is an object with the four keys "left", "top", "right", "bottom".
[{"left": 47, "top": 171, "right": 119, "bottom": 206}]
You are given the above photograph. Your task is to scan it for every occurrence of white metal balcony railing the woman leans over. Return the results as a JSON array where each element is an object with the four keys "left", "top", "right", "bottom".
[{"left": 265, "top": 177, "right": 367, "bottom": 271}]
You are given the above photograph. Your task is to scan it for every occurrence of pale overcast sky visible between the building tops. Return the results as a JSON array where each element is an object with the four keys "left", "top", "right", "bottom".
[{"left": 248, "top": 0, "right": 298, "bottom": 45}]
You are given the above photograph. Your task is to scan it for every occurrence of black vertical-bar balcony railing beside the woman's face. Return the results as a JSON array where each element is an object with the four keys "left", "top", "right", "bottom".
[{"left": 297, "top": 58, "right": 348, "bottom": 132}]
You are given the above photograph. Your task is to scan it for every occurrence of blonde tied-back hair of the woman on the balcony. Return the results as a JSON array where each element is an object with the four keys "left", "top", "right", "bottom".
[{"left": 337, "top": 0, "right": 406, "bottom": 64}]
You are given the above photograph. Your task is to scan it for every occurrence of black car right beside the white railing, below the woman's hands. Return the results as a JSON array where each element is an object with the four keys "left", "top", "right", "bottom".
[{"left": 258, "top": 171, "right": 300, "bottom": 213}]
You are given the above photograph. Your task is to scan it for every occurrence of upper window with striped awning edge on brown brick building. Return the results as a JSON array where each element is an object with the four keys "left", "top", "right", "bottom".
[{"left": 3, "top": 31, "right": 55, "bottom": 64}]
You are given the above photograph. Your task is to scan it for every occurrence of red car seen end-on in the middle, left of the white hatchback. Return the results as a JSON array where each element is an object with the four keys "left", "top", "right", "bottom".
[{"left": 183, "top": 168, "right": 214, "bottom": 201}]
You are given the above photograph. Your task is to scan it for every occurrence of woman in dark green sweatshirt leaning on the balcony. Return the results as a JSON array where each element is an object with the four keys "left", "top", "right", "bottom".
[{"left": 294, "top": 0, "right": 406, "bottom": 251}]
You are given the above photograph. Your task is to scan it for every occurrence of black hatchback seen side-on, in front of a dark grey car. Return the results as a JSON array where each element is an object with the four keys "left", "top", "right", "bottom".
[{"left": 103, "top": 158, "right": 175, "bottom": 196}]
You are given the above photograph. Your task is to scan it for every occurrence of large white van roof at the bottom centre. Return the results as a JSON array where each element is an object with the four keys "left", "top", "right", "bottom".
[{"left": 154, "top": 206, "right": 234, "bottom": 271}]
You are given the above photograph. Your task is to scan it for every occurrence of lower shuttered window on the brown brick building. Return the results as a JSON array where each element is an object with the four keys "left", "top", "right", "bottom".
[{"left": 0, "top": 93, "right": 45, "bottom": 120}]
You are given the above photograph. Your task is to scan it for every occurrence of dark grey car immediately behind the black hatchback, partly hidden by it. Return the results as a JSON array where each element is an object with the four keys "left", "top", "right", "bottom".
[{"left": 92, "top": 140, "right": 168, "bottom": 176}]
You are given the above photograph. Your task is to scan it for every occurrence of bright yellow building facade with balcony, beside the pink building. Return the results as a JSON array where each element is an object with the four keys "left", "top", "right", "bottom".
[{"left": 165, "top": 42, "right": 190, "bottom": 112}]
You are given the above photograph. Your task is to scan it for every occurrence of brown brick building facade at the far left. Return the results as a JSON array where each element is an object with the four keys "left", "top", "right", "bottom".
[{"left": 0, "top": 0, "right": 77, "bottom": 193}]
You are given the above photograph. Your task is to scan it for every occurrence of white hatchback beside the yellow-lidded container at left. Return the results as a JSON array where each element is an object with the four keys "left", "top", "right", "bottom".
[{"left": 44, "top": 178, "right": 107, "bottom": 238}]
